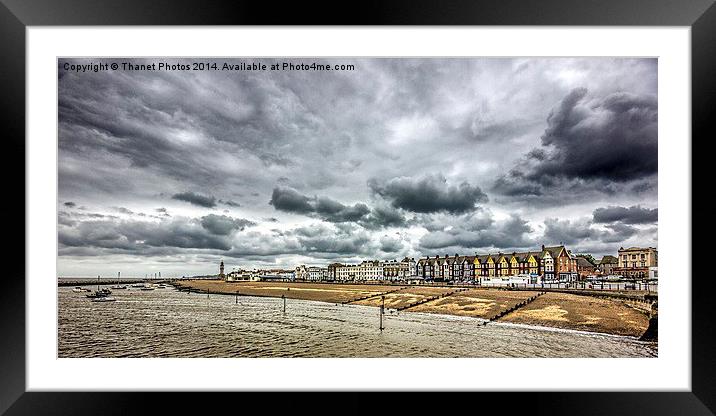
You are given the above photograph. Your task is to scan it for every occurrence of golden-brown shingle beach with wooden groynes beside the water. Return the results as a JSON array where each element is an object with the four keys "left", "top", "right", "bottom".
[{"left": 171, "top": 280, "right": 651, "bottom": 342}]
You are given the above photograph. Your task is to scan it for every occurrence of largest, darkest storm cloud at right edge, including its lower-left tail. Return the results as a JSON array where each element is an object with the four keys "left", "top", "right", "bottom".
[{"left": 493, "top": 88, "right": 658, "bottom": 196}]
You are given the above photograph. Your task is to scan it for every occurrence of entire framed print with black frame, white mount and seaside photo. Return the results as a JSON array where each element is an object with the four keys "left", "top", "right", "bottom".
[{"left": 0, "top": 2, "right": 716, "bottom": 414}]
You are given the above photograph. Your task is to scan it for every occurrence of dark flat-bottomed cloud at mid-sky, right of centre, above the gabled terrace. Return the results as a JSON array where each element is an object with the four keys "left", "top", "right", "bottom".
[{"left": 368, "top": 175, "right": 488, "bottom": 214}]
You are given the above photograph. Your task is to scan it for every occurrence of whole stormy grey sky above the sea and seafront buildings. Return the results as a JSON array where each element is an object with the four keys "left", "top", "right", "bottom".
[{"left": 57, "top": 58, "right": 658, "bottom": 277}]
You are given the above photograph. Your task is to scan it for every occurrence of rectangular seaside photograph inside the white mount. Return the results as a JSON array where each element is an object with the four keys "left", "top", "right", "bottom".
[{"left": 58, "top": 56, "right": 656, "bottom": 361}]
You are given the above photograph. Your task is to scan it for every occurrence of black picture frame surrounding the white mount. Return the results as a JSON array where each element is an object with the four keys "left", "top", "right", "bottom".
[{"left": 0, "top": 0, "right": 716, "bottom": 416}]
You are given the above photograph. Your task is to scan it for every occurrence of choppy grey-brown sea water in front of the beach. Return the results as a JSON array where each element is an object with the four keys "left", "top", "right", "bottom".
[{"left": 58, "top": 286, "right": 657, "bottom": 358}]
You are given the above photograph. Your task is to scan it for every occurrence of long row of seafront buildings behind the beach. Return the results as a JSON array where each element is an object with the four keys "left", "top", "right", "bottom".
[{"left": 219, "top": 244, "right": 658, "bottom": 286}]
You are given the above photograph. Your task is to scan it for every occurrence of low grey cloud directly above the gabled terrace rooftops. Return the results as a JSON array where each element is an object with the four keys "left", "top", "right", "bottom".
[{"left": 420, "top": 215, "right": 535, "bottom": 251}]
